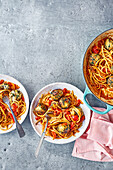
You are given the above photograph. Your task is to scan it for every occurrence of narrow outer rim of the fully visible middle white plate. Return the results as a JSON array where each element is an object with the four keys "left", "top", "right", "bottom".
[{"left": 29, "top": 82, "right": 91, "bottom": 144}]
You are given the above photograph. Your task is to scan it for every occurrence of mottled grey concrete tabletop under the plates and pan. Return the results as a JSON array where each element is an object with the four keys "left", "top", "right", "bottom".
[{"left": 0, "top": 0, "right": 113, "bottom": 170}]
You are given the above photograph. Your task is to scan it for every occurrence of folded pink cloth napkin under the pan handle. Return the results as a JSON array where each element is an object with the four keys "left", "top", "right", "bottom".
[{"left": 72, "top": 108, "right": 113, "bottom": 162}]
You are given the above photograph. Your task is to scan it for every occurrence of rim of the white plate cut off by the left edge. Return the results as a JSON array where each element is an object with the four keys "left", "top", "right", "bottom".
[{"left": 0, "top": 74, "right": 29, "bottom": 135}]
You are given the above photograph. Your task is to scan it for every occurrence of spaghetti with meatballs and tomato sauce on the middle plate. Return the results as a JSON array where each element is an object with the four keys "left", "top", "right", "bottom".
[{"left": 33, "top": 88, "right": 85, "bottom": 139}]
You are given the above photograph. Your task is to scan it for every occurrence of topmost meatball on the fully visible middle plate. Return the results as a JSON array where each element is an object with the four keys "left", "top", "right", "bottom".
[{"left": 51, "top": 89, "right": 63, "bottom": 100}]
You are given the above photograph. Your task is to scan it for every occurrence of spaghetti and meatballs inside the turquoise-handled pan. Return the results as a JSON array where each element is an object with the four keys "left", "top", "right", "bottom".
[{"left": 87, "top": 37, "right": 113, "bottom": 105}]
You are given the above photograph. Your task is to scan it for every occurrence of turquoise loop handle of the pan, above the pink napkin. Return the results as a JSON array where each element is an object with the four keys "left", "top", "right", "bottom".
[{"left": 83, "top": 86, "right": 113, "bottom": 115}]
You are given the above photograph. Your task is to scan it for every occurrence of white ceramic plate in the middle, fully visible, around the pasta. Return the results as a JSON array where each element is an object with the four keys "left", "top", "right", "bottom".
[{"left": 30, "top": 83, "right": 90, "bottom": 144}]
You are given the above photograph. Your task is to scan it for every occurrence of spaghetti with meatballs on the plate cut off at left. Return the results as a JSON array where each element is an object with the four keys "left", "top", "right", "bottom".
[{"left": 0, "top": 80, "right": 26, "bottom": 131}]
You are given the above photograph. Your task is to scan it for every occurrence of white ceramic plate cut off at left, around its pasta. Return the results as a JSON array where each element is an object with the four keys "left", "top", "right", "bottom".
[{"left": 0, "top": 74, "right": 29, "bottom": 134}]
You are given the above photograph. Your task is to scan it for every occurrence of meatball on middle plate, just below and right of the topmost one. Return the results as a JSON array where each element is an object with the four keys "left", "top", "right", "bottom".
[{"left": 59, "top": 97, "right": 71, "bottom": 109}]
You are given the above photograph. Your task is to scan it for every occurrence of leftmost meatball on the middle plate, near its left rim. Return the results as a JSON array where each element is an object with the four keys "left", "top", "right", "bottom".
[{"left": 34, "top": 103, "right": 48, "bottom": 114}]
